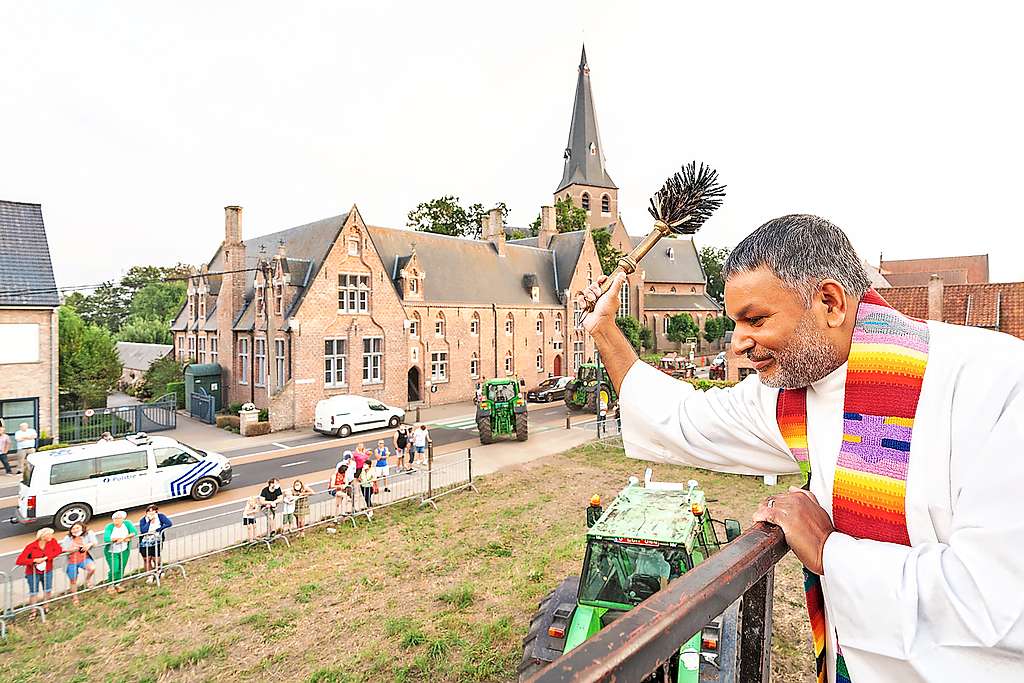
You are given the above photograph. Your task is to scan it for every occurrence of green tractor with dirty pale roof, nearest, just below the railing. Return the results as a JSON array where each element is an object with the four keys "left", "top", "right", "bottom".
[{"left": 519, "top": 469, "right": 739, "bottom": 683}]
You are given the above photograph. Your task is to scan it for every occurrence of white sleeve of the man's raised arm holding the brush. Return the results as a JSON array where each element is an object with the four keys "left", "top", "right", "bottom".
[{"left": 620, "top": 360, "right": 800, "bottom": 474}]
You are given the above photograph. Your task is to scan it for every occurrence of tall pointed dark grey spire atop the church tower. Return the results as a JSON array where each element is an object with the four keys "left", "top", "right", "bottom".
[{"left": 555, "top": 45, "right": 616, "bottom": 194}]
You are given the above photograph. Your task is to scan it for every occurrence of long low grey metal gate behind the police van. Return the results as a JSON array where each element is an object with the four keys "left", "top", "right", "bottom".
[{"left": 59, "top": 394, "right": 178, "bottom": 443}]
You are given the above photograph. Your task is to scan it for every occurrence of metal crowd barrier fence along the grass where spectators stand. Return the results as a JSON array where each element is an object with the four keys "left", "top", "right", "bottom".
[{"left": 0, "top": 446, "right": 476, "bottom": 638}]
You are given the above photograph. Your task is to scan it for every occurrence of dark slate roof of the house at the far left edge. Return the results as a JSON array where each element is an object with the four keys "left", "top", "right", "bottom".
[{"left": 0, "top": 200, "right": 60, "bottom": 307}]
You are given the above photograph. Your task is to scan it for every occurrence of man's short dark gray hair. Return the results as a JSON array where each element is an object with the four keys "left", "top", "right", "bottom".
[{"left": 722, "top": 214, "right": 871, "bottom": 306}]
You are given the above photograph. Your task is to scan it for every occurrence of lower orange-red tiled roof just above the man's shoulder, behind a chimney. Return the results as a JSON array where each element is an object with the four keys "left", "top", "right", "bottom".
[{"left": 878, "top": 283, "right": 1024, "bottom": 339}]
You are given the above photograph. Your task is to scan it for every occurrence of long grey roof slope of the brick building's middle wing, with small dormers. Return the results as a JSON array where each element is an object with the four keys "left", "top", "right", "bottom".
[{"left": 367, "top": 226, "right": 560, "bottom": 305}]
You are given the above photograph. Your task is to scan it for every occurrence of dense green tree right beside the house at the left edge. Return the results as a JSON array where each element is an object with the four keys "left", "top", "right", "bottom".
[{"left": 57, "top": 306, "right": 122, "bottom": 410}]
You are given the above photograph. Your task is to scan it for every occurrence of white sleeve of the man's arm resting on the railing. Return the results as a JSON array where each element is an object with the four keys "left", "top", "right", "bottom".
[{"left": 823, "top": 393, "right": 1024, "bottom": 659}]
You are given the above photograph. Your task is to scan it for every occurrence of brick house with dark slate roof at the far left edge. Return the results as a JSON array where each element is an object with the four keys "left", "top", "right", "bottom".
[{"left": 0, "top": 201, "right": 60, "bottom": 437}]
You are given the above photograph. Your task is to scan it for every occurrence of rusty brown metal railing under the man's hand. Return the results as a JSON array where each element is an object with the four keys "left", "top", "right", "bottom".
[{"left": 529, "top": 523, "right": 790, "bottom": 683}]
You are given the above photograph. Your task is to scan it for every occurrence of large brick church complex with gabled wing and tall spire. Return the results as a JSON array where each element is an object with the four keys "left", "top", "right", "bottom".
[{"left": 171, "top": 50, "right": 722, "bottom": 430}]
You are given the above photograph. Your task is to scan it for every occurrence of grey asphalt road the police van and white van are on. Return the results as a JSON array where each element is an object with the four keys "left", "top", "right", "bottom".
[{"left": 0, "top": 401, "right": 577, "bottom": 557}]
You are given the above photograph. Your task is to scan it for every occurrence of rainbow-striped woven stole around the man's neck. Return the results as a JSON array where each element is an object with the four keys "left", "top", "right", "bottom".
[{"left": 775, "top": 290, "right": 928, "bottom": 683}]
